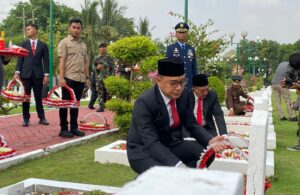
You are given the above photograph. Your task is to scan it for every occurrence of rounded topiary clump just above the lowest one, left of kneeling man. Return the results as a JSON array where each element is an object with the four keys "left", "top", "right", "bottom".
[{"left": 105, "top": 98, "right": 133, "bottom": 115}]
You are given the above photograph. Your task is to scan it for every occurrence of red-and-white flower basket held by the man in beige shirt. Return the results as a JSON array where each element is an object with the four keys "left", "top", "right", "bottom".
[{"left": 43, "top": 85, "right": 80, "bottom": 108}]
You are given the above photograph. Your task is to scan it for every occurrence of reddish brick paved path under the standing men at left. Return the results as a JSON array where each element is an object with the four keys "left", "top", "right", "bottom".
[{"left": 0, "top": 107, "right": 114, "bottom": 155}]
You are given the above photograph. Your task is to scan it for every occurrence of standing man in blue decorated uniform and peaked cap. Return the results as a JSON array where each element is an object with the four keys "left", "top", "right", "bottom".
[{"left": 167, "top": 22, "right": 197, "bottom": 89}]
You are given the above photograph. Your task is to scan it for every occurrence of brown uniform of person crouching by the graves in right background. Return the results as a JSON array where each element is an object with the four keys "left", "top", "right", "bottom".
[{"left": 226, "top": 85, "right": 248, "bottom": 115}]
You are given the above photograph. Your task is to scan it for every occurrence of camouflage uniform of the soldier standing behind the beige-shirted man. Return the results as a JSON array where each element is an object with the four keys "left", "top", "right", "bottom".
[{"left": 95, "top": 55, "right": 114, "bottom": 109}]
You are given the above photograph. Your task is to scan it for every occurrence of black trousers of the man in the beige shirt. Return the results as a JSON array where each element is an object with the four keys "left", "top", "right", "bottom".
[{"left": 59, "top": 78, "right": 85, "bottom": 131}]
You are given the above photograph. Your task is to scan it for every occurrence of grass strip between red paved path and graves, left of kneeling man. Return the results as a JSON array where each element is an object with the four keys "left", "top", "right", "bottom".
[{"left": 0, "top": 133, "right": 136, "bottom": 188}]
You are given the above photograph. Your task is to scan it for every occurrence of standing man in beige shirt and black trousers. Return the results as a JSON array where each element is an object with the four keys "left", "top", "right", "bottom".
[{"left": 57, "top": 19, "right": 90, "bottom": 138}]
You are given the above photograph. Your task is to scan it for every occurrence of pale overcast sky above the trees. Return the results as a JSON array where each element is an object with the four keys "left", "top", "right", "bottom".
[{"left": 0, "top": 0, "right": 300, "bottom": 43}]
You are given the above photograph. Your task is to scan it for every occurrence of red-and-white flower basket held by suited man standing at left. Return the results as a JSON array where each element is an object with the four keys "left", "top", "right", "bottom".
[{"left": 1, "top": 79, "right": 30, "bottom": 102}]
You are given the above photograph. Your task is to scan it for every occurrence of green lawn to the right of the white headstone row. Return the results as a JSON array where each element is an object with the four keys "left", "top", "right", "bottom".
[{"left": 267, "top": 93, "right": 300, "bottom": 195}]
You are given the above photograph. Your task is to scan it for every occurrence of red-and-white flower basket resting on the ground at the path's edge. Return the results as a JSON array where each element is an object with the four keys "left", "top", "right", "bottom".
[{"left": 78, "top": 112, "right": 109, "bottom": 131}]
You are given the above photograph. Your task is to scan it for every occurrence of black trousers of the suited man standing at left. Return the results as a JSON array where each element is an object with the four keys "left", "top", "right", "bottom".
[{"left": 22, "top": 77, "right": 45, "bottom": 120}]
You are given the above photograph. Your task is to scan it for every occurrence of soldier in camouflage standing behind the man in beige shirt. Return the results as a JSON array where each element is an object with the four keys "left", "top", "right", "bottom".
[{"left": 89, "top": 43, "right": 114, "bottom": 112}]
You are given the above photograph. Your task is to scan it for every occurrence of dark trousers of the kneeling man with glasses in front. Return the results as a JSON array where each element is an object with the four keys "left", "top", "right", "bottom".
[{"left": 129, "top": 141, "right": 207, "bottom": 174}]
